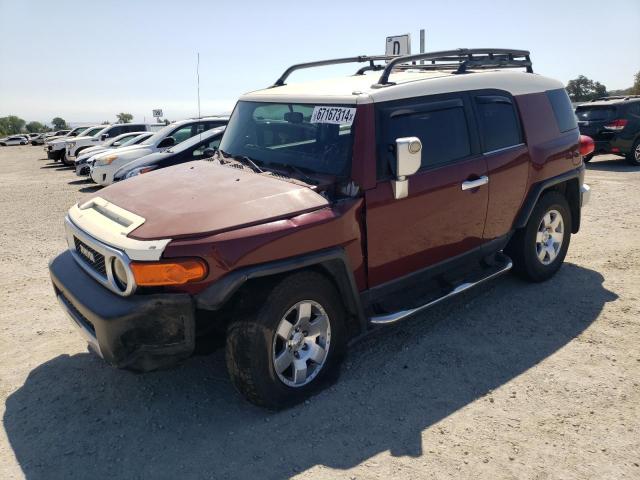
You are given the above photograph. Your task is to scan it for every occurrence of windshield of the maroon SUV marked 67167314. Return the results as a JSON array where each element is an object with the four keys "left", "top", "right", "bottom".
[{"left": 220, "top": 102, "right": 355, "bottom": 175}]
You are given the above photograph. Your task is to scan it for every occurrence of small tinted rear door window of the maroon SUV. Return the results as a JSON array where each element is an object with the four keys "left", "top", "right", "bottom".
[{"left": 475, "top": 95, "right": 522, "bottom": 153}]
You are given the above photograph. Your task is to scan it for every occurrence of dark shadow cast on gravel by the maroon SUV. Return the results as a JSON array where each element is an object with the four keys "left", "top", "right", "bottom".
[{"left": 4, "top": 264, "right": 617, "bottom": 479}]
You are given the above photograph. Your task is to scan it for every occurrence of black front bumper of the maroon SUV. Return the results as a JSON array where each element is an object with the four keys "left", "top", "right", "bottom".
[{"left": 49, "top": 250, "right": 195, "bottom": 371}]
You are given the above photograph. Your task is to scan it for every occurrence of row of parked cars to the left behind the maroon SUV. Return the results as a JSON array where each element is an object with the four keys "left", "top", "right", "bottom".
[{"left": 44, "top": 116, "right": 229, "bottom": 185}]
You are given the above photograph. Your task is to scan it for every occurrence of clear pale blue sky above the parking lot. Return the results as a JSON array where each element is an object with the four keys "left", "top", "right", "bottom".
[{"left": 0, "top": 0, "right": 640, "bottom": 122}]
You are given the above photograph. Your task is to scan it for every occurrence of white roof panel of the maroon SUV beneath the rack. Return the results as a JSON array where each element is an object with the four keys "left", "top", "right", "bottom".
[{"left": 240, "top": 69, "right": 564, "bottom": 104}]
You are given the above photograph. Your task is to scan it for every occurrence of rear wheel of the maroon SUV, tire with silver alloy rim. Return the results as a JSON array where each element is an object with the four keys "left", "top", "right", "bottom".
[{"left": 505, "top": 191, "right": 572, "bottom": 282}]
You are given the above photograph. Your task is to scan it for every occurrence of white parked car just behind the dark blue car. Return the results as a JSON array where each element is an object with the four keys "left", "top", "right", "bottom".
[{"left": 90, "top": 116, "right": 229, "bottom": 185}]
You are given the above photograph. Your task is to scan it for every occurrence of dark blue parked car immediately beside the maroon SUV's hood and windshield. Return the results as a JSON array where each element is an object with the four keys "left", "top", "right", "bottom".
[{"left": 113, "top": 127, "right": 225, "bottom": 182}]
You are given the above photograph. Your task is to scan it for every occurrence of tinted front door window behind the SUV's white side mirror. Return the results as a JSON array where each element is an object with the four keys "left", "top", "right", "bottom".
[{"left": 378, "top": 99, "right": 471, "bottom": 177}]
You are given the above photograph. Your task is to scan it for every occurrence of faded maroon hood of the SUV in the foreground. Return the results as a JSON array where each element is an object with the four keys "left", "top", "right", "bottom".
[{"left": 99, "top": 160, "right": 329, "bottom": 240}]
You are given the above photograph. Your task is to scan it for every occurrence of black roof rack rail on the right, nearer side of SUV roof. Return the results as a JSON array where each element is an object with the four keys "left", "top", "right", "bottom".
[{"left": 373, "top": 48, "right": 533, "bottom": 88}]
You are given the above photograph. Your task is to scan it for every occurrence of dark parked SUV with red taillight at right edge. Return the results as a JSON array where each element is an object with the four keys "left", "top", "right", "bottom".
[{"left": 576, "top": 95, "right": 640, "bottom": 166}]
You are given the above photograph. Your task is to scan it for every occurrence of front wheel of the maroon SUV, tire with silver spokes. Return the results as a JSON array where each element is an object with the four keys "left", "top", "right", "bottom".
[{"left": 226, "top": 271, "right": 346, "bottom": 410}]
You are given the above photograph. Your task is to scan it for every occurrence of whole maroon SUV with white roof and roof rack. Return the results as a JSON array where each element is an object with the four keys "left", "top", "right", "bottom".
[{"left": 49, "top": 49, "right": 593, "bottom": 408}]
